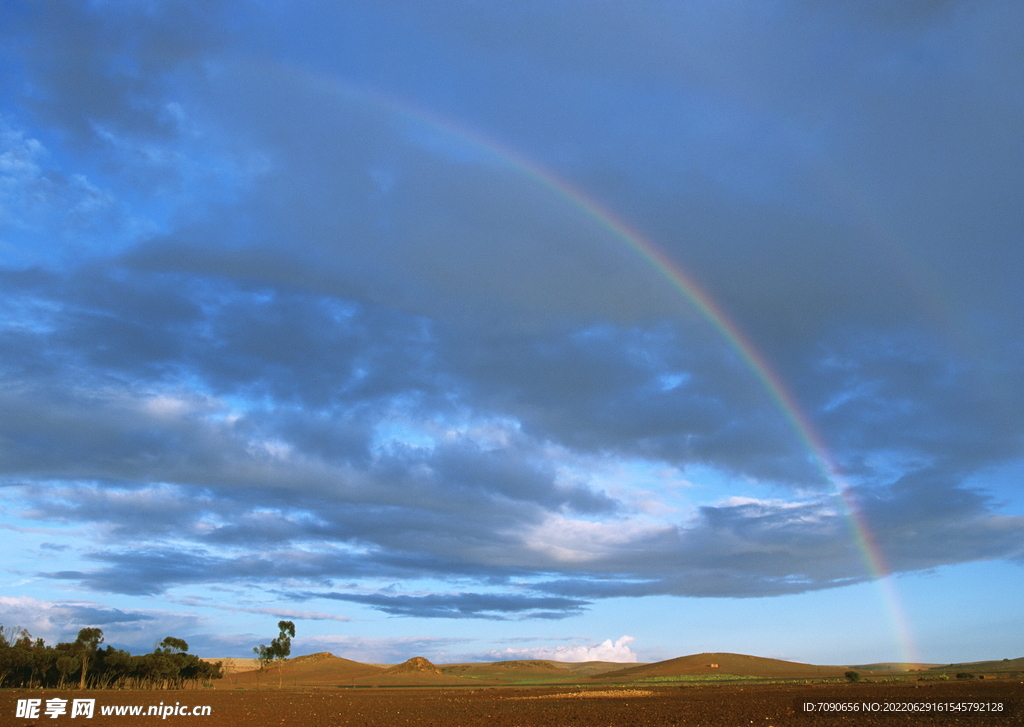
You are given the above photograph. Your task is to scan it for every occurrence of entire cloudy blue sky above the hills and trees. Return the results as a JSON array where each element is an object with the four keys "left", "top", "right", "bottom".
[{"left": 0, "top": 0, "right": 1024, "bottom": 664}]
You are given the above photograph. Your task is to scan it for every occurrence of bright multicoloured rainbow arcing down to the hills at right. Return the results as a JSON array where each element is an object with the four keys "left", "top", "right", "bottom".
[{"left": 314, "top": 72, "right": 919, "bottom": 665}]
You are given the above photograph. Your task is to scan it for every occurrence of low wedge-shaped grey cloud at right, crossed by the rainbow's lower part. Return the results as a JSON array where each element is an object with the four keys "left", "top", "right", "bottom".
[{"left": 534, "top": 488, "right": 1024, "bottom": 599}]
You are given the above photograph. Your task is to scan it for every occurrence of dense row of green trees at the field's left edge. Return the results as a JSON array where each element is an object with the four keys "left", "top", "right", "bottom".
[{"left": 0, "top": 626, "right": 223, "bottom": 689}]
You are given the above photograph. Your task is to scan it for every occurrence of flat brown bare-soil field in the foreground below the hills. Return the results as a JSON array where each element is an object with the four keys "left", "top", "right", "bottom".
[{"left": 0, "top": 679, "right": 1024, "bottom": 727}]
